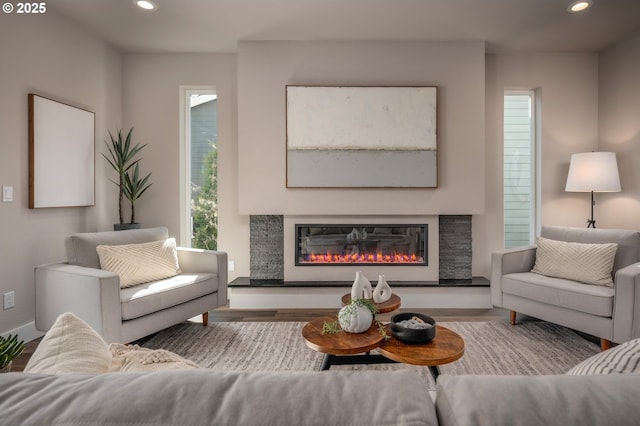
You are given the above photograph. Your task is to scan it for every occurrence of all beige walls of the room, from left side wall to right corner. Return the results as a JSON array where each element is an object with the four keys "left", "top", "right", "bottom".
[{"left": 0, "top": 12, "right": 640, "bottom": 333}]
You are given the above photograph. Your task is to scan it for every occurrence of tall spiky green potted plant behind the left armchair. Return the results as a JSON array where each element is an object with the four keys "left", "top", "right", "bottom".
[{"left": 102, "top": 127, "right": 151, "bottom": 231}]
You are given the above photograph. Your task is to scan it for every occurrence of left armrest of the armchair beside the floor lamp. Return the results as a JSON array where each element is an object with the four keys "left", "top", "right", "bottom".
[{"left": 491, "top": 246, "right": 536, "bottom": 307}]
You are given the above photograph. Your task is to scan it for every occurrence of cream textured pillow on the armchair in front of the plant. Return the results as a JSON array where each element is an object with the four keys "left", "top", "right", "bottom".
[{"left": 96, "top": 238, "right": 180, "bottom": 288}]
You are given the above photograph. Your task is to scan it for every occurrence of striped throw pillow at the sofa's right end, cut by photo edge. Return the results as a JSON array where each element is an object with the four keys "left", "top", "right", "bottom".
[{"left": 567, "top": 339, "right": 640, "bottom": 375}]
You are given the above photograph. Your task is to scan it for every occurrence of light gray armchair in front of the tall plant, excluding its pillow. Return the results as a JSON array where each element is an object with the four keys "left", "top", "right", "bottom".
[{"left": 35, "top": 227, "right": 227, "bottom": 343}]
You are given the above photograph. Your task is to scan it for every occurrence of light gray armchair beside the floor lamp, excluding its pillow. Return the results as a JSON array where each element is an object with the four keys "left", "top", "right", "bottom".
[{"left": 491, "top": 226, "right": 640, "bottom": 350}]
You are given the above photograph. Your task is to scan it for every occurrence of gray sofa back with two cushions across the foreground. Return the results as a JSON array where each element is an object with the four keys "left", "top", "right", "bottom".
[{"left": 0, "top": 369, "right": 640, "bottom": 426}]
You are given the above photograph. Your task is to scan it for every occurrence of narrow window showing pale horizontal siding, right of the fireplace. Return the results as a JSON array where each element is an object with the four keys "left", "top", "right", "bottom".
[{"left": 504, "top": 90, "right": 537, "bottom": 248}]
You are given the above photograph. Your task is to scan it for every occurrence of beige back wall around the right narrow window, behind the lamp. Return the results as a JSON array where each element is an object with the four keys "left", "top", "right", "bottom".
[{"left": 480, "top": 53, "right": 605, "bottom": 277}]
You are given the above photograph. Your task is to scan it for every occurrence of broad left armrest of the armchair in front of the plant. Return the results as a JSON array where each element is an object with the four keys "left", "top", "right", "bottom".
[{"left": 35, "top": 263, "right": 122, "bottom": 341}]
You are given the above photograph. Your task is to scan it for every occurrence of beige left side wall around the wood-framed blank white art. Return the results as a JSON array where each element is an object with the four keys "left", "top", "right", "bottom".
[{"left": 0, "top": 11, "right": 122, "bottom": 336}]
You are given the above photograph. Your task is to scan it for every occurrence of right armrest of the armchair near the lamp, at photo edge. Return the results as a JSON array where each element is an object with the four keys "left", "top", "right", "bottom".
[{"left": 612, "top": 262, "right": 640, "bottom": 343}]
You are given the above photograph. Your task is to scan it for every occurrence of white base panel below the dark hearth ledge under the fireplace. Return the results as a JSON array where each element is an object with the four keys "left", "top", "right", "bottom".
[{"left": 229, "top": 286, "right": 492, "bottom": 309}]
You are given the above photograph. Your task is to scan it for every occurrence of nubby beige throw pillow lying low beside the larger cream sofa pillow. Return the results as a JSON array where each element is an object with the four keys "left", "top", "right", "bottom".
[{"left": 109, "top": 343, "right": 200, "bottom": 372}]
